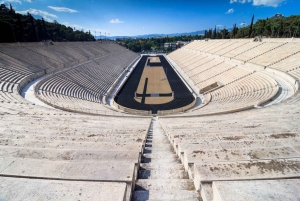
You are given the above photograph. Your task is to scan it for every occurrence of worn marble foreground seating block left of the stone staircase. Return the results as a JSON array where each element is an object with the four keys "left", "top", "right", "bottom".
[{"left": 0, "top": 99, "right": 151, "bottom": 200}]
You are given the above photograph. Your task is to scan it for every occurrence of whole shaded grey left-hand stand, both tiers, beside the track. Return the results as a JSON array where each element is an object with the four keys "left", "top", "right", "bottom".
[{"left": 0, "top": 42, "right": 139, "bottom": 114}]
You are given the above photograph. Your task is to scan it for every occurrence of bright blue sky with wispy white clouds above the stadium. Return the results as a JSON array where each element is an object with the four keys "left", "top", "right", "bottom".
[{"left": 0, "top": 0, "right": 300, "bottom": 36}]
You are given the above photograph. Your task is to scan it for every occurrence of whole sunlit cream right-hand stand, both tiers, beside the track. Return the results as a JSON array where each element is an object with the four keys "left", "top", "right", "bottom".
[{"left": 168, "top": 39, "right": 300, "bottom": 115}]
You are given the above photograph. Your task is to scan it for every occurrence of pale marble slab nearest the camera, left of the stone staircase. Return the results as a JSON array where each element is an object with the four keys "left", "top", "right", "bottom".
[{"left": 0, "top": 177, "right": 126, "bottom": 201}]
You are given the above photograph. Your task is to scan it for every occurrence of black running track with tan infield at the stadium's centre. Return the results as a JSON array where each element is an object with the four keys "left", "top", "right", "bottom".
[{"left": 114, "top": 55, "right": 196, "bottom": 114}]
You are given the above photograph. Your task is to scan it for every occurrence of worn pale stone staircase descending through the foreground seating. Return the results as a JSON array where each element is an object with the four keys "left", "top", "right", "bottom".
[{"left": 132, "top": 117, "right": 201, "bottom": 201}]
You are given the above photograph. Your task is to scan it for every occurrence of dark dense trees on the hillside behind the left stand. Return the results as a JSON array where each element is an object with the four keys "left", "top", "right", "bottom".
[{"left": 0, "top": 4, "right": 95, "bottom": 43}]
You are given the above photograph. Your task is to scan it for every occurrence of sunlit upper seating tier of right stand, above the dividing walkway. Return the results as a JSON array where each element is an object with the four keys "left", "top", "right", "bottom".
[{"left": 182, "top": 39, "right": 300, "bottom": 73}]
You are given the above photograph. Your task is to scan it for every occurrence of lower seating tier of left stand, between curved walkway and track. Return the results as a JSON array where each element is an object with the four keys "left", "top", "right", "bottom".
[{"left": 36, "top": 50, "right": 138, "bottom": 114}]
